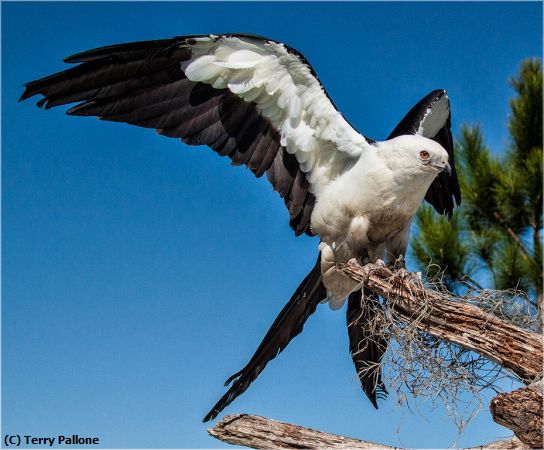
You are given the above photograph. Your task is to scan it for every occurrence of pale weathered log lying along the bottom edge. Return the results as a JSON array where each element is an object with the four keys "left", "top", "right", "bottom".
[{"left": 208, "top": 414, "right": 524, "bottom": 450}]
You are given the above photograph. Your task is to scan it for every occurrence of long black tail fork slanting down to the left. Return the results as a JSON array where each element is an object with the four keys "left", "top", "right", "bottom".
[{"left": 204, "top": 254, "right": 327, "bottom": 422}]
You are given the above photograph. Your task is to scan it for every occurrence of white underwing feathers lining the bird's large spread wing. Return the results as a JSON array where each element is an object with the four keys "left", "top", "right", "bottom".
[{"left": 182, "top": 36, "right": 369, "bottom": 193}]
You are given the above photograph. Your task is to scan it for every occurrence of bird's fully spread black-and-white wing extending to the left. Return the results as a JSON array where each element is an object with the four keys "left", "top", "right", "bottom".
[{"left": 21, "top": 34, "right": 371, "bottom": 235}]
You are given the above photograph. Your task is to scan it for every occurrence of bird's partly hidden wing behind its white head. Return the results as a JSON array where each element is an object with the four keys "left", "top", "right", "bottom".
[{"left": 388, "top": 89, "right": 461, "bottom": 216}]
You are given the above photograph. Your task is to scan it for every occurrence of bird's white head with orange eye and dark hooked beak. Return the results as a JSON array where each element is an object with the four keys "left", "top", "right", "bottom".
[{"left": 379, "top": 135, "right": 451, "bottom": 179}]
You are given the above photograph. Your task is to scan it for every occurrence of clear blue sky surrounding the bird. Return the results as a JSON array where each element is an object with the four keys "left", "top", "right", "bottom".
[{"left": 2, "top": 2, "right": 542, "bottom": 447}]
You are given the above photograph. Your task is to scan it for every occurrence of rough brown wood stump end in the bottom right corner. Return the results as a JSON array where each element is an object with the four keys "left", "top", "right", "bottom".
[{"left": 489, "top": 382, "right": 544, "bottom": 448}]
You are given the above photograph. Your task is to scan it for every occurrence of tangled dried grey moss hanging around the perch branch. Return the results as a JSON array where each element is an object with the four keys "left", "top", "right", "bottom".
[{"left": 352, "top": 264, "right": 538, "bottom": 434}]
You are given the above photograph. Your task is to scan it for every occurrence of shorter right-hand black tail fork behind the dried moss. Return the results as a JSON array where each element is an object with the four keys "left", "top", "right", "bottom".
[{"left": 347, "top": 288, "right": 387, "bottom": 409}]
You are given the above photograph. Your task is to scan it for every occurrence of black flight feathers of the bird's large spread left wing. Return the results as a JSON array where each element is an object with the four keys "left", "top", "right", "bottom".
[{"left": 20, "top": 34, "right": 315, "bottom": 236}]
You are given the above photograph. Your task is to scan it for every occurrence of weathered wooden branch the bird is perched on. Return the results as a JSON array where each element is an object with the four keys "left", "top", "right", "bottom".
[{"left": 339, "top": 264, "right": 543, "bottom": 383}]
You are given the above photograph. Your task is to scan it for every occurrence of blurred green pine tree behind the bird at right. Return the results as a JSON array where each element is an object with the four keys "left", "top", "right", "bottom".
[{"left": 412, "top": 59, "right": 543, "bottom": 309}]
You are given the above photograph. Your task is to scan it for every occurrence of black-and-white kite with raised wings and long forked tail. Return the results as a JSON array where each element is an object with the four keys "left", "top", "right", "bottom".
[{"left": 20, "top": 33, "right": 461, "bottom": 422}]
